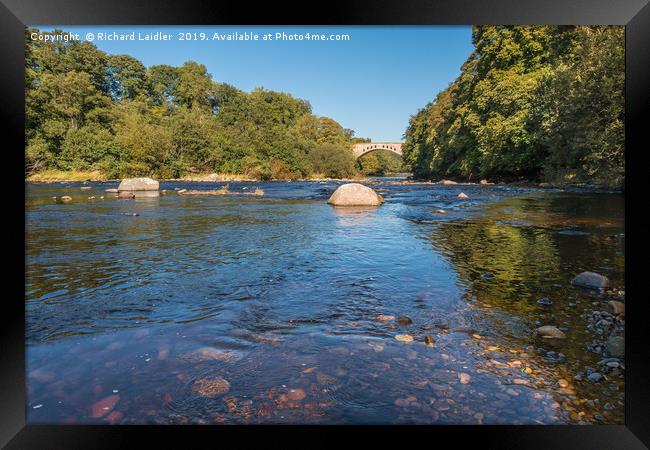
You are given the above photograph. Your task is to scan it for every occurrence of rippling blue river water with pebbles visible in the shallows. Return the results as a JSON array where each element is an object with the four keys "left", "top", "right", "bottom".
[{"left": 26, "top": 179, "right": 625, "bottom": 424}]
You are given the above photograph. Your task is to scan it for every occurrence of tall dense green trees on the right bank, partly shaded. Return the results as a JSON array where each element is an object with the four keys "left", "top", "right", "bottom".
[{"left": 403, "top": 26, "right": 625, "bottom": 187}]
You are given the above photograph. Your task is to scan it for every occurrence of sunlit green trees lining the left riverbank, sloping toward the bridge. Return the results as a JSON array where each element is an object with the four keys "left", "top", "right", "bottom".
[{"left": 25, "top": 29, "right": 358, "bottom": 181}]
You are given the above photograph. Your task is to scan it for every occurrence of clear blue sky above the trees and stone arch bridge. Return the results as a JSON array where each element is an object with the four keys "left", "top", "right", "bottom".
[{"left": 36, "top": 25, "right": 473, "bottom": 141}]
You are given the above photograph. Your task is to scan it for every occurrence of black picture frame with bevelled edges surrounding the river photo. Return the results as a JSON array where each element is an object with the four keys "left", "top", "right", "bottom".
[{"left": 0, "top": 0, "right": 650, "bottom": 449}]
